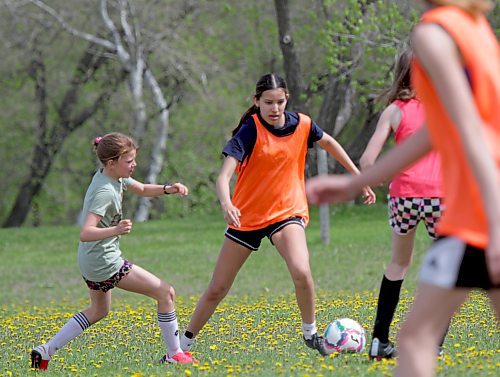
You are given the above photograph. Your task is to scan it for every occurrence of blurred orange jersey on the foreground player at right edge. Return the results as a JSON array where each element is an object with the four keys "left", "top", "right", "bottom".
[{"left": 413, "top": 6, "right": 500, "bottom": 248}]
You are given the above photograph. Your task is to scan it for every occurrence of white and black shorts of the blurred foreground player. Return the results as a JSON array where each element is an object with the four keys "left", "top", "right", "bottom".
[{"left": 420, "top": 237, "right": 500, "bottom": 290}]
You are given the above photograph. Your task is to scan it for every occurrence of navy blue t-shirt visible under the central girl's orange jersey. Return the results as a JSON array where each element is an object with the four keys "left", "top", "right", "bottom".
[{"left": 222, "top": 111, "right": 323, "bottom": 162}]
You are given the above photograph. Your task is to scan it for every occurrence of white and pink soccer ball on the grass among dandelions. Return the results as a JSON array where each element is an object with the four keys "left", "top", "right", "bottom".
[{"left": 323, "top": 318, "right": 366, "bottom": 354}]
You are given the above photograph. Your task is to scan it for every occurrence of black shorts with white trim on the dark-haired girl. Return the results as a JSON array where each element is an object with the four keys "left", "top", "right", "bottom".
[{"left": 225, "top": 216, "right": 305, "bottom": 251}]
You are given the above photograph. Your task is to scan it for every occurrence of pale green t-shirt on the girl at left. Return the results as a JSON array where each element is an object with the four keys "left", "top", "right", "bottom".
[{"left": 78, "top": 170, "right": 132, "bottom": 282}]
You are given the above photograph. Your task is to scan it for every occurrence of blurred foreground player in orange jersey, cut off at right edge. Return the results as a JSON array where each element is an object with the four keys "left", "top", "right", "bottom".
[{"left": 307, "top": 0, "right": 500, "bottom": 377}]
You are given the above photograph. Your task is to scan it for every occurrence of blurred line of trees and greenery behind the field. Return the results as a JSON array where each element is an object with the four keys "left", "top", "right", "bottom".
[{"left": 0, "top": 0, "right": 500, "bottom": 227}]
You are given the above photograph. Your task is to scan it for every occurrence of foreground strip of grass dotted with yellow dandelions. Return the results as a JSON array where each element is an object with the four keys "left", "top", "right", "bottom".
[{"left": 0, "top": 292, "right": 500, "bottom": 377}]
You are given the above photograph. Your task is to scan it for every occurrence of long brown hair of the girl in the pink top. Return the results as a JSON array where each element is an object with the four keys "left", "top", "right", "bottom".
[{"left": 377, "top": 48, "right": 415, "bottom": 106}]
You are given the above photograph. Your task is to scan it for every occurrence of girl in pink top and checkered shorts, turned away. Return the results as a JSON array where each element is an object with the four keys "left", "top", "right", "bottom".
[{"left": 359, "top": 49, "right": 444, "bottom": 360}]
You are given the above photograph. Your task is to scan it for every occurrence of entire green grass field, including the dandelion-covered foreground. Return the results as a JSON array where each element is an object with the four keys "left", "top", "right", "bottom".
[{"left": 0, "top": 205, "right": 500, "bottom": 377}]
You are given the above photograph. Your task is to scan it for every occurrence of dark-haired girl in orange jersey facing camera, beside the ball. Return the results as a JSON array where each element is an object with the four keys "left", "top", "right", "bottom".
[{"left": 181, "top": 74, "right": 375, "bottom": 355}]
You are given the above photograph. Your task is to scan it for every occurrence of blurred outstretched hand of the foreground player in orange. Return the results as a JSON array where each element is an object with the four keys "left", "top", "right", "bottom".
[{"left": 306, "top": 174, "right": 360, "bottom": 205}]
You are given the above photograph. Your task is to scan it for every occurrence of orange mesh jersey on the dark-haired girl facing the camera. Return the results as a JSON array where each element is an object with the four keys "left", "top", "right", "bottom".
[{"left": 232, "top": 114, "right": 311, "bottom": 230}]
